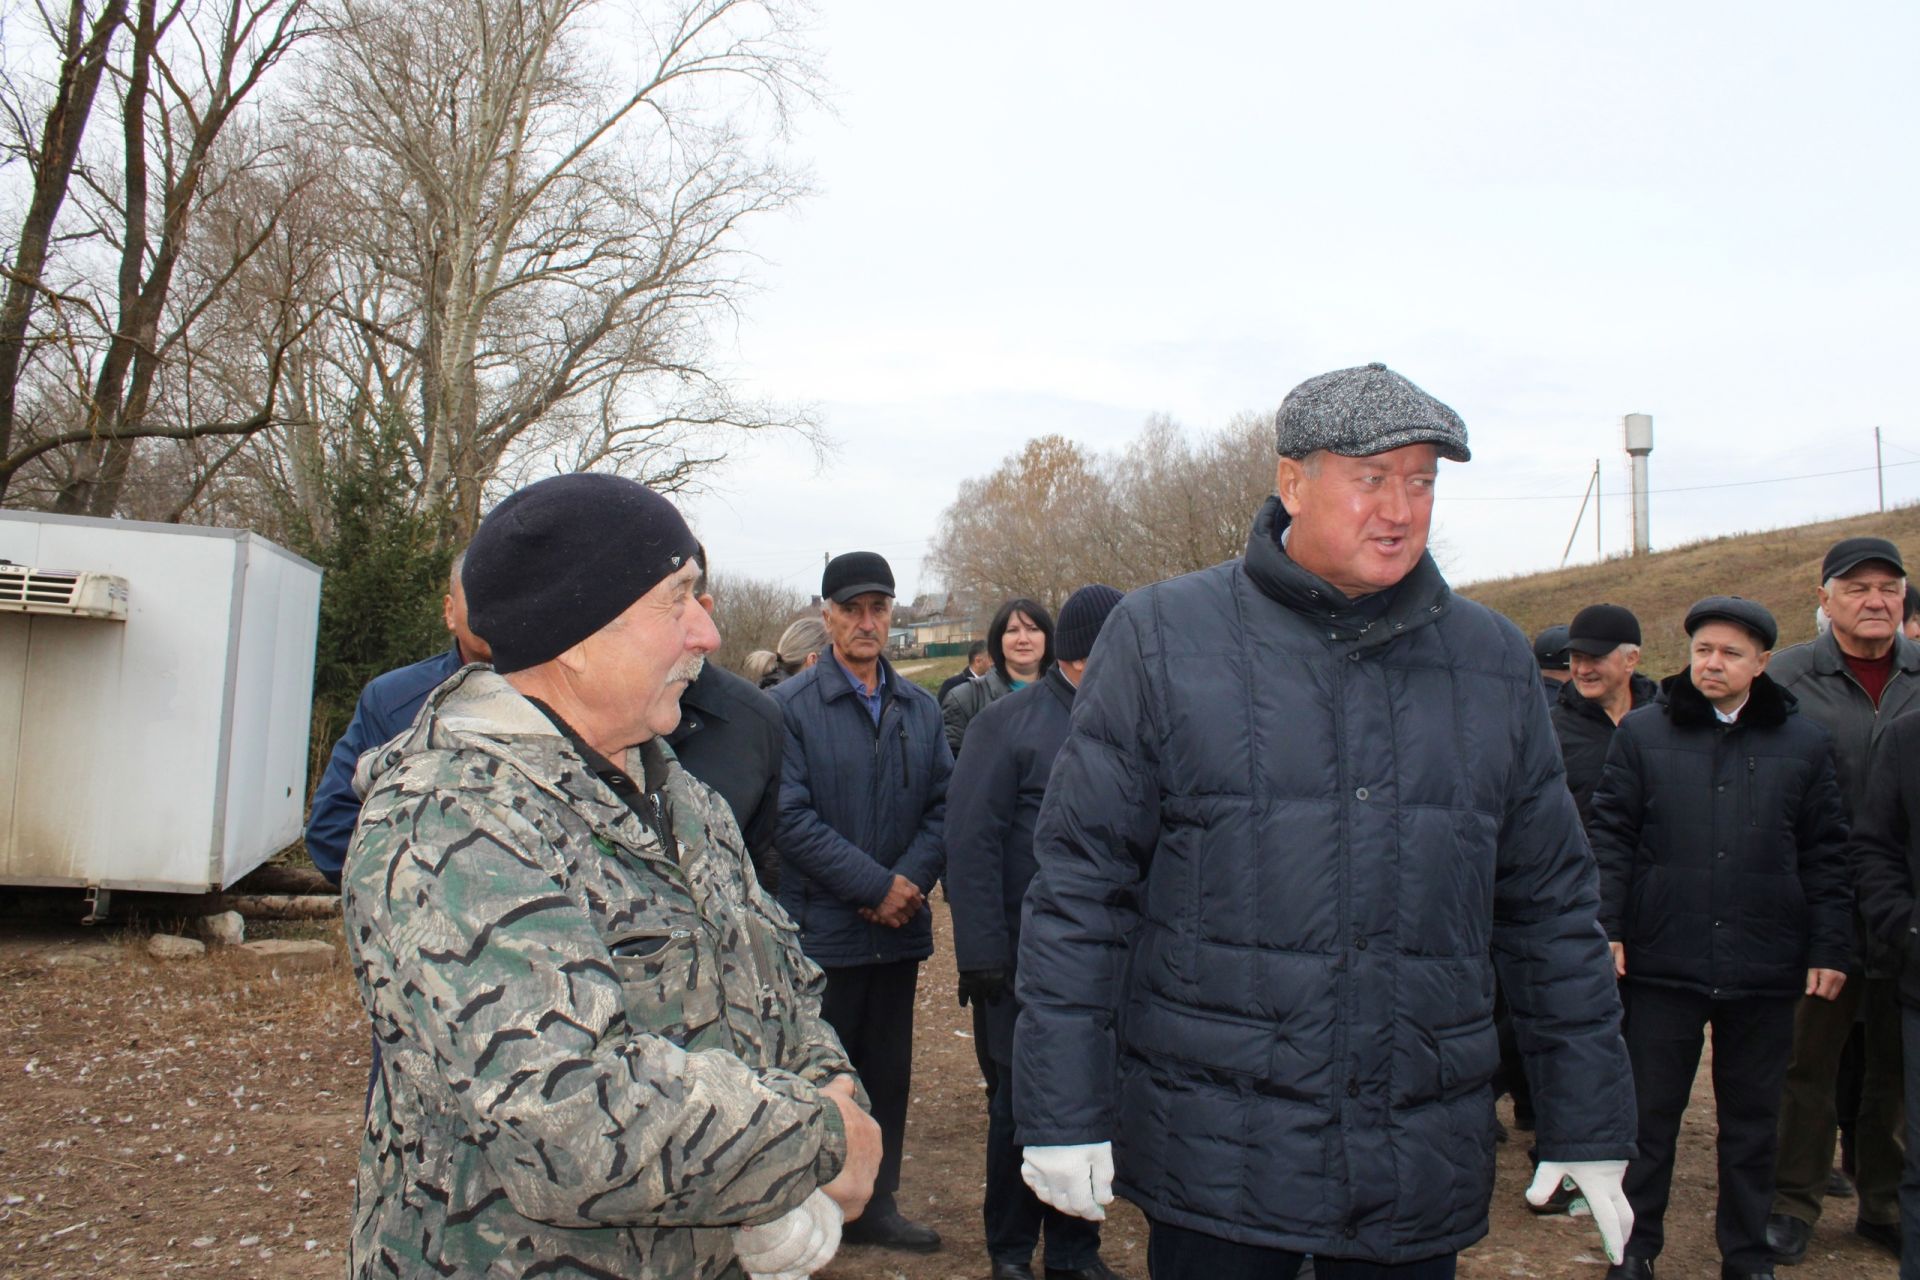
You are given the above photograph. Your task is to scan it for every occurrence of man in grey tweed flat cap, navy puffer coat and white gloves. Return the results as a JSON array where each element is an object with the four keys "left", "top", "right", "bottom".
[{"left": 1014, "top": 365, "right": 1634, "bottom": 1280}]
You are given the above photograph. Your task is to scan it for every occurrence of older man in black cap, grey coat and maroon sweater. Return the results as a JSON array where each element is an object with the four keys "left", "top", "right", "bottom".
[{"left": 1766, "top": 537, "right": 1920, "bottom": 1263}]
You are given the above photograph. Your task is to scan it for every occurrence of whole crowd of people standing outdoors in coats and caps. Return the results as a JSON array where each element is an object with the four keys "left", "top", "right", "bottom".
[{"left": 309, "top": 365, "right": 1920, "bottom": 1280}]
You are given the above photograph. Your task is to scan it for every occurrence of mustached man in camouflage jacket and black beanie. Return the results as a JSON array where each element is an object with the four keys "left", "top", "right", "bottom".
[{"left": 342, "top": 474, "right": 879, "bottom": 1280}]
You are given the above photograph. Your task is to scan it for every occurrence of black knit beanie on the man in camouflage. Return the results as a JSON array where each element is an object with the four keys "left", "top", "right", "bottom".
[{"left": 461, "top": 472, "right": 697, "bottom": 674}]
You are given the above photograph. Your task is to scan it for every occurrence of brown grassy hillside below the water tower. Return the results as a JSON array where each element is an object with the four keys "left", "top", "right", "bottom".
[{"left": 1459, "top": 507, "right": 1920, "bottom": 679}]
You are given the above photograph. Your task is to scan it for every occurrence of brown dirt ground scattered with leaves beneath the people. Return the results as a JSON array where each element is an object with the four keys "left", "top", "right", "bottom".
[{"left": 0, "top": 904, "right": 1897, "bottom": 1280}]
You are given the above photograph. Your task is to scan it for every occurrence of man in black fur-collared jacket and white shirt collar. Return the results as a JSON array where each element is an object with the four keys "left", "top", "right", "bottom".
[{"left": 1588, "top": 595, "right": 1853, "bottom": 1280}]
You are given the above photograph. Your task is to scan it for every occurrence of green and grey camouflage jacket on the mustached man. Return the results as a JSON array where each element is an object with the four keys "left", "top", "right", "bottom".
[{"left": 342, "top": 666, "right": 866, "bottom": 1280}]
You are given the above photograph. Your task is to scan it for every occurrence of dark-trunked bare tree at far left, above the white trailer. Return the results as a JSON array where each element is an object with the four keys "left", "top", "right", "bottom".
[{"left": 0, "top": 0, "right": 313, "bottom": 516}]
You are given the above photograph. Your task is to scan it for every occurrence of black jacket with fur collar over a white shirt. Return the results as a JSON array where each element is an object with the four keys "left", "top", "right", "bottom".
[{"left": 1588, "top": 672, "right": 1853, "bottom": 1000}]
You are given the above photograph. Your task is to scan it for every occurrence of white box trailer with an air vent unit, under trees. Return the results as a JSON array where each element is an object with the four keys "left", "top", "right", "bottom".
[{"left": 0, "top": 510, "right": 321, "bottom": 892}]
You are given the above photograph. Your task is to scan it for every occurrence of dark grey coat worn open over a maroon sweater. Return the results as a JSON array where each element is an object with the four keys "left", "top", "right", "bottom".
[{"left": 1766, "top": 631, "right": 1920, "bottom": 977}]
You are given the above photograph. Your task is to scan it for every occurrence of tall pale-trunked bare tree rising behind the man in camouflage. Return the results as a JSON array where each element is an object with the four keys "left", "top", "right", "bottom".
[{"left": 309, "top": 0, "right": 814, "bottom": 537}]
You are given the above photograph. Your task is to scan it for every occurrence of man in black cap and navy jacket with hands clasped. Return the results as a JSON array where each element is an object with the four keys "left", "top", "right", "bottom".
[{"left": 772, "top": 551, "right": 952, "bottom": 1253}]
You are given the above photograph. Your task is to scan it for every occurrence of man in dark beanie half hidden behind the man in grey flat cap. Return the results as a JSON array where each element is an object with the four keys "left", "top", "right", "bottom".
[{"left": 947, "top": 583, "right": 1119, "bottom": 1280}]
